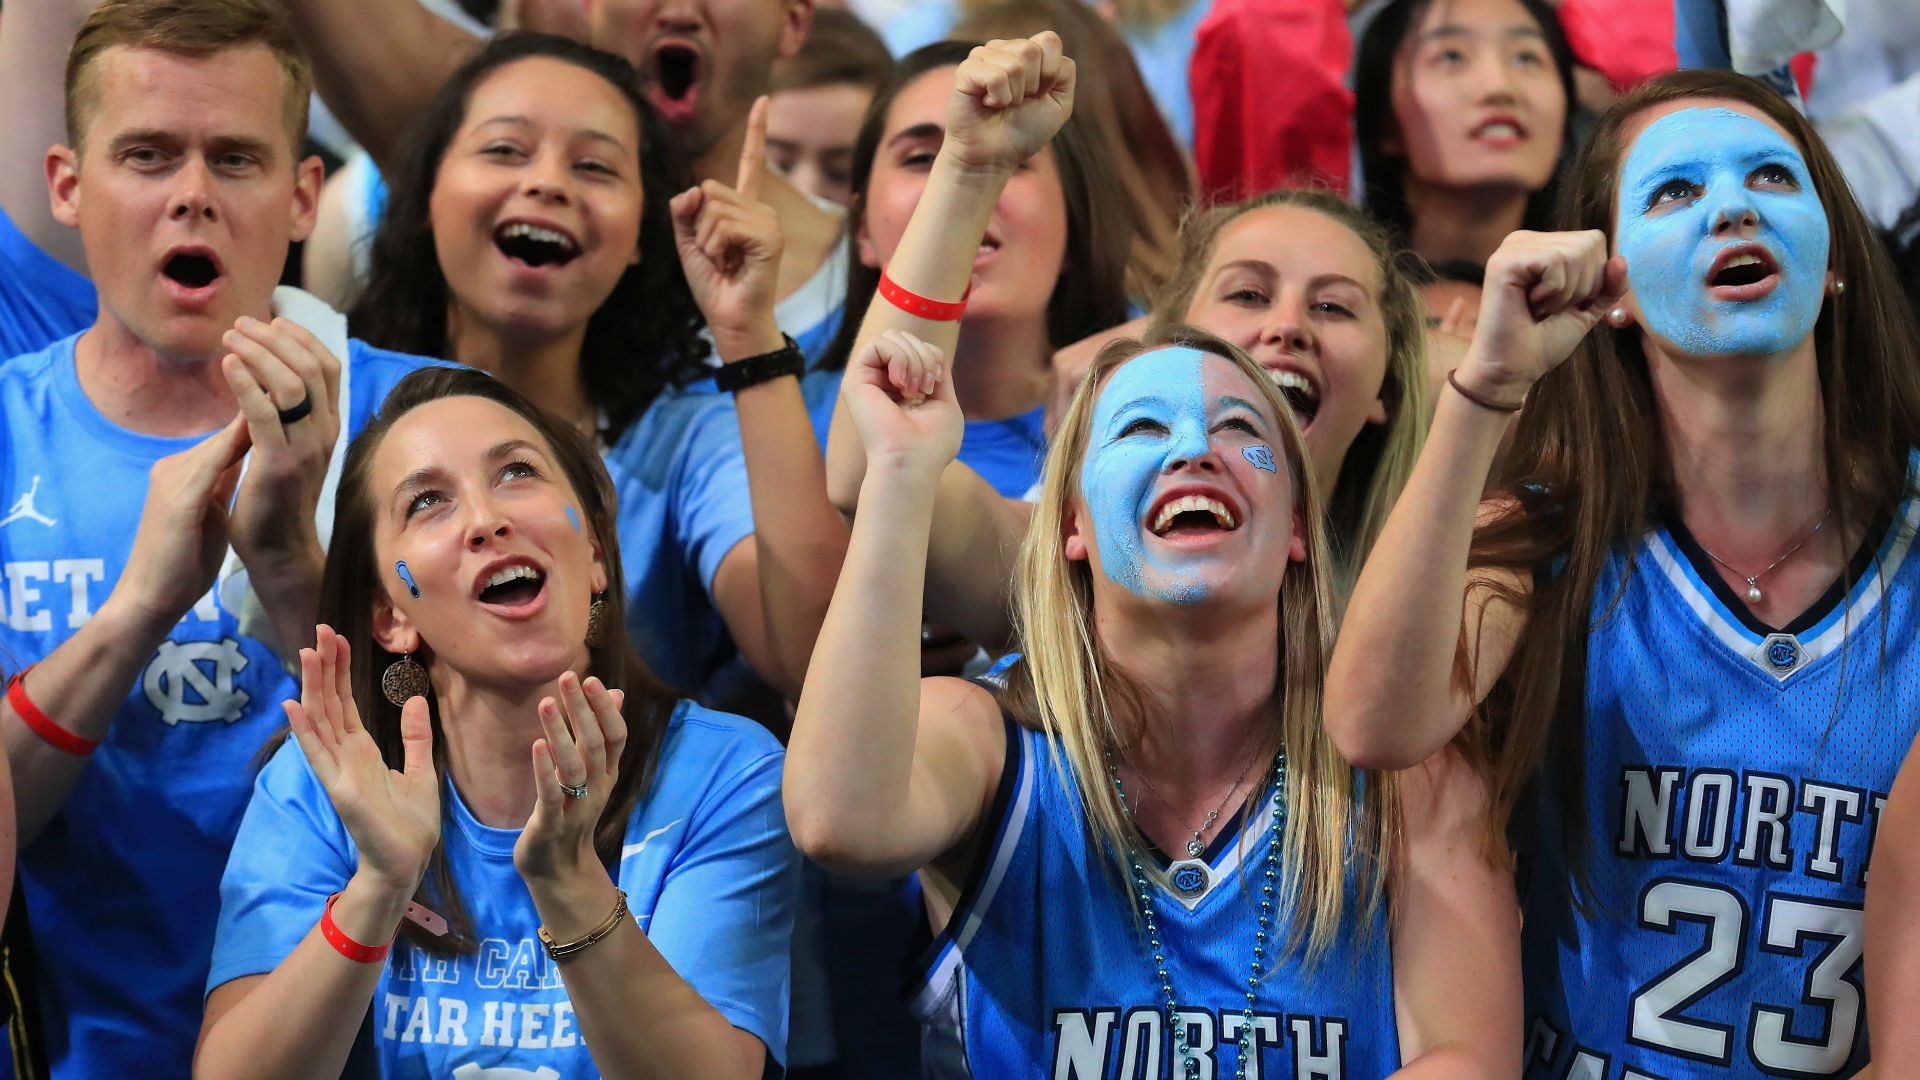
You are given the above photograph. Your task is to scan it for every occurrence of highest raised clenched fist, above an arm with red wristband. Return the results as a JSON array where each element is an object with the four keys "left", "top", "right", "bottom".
[{"left": 941, "top": 31, "right": 1075, "bottom": 173}]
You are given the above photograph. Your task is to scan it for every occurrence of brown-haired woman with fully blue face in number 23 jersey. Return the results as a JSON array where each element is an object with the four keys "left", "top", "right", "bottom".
[{"left": 1327, "top": 71, "right": 1920, "bottom": 1076}]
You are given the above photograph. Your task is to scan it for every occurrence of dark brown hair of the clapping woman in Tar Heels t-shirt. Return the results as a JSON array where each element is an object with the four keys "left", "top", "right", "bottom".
[{"left": 319, "top": 367, "right": 676, "bottom": 953}]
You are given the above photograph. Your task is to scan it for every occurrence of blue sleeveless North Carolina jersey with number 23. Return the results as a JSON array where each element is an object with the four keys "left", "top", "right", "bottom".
[{"left": 1524, "top": 484, "right": 1920, "bottom": 1080}]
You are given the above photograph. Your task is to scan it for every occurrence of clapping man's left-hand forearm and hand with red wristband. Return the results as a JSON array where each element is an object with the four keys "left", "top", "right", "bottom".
[{"left": 0, "top": 411, "right": 248, "bottom": 846}]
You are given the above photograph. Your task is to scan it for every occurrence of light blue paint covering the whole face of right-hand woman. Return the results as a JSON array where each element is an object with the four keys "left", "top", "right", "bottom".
[{"left": 1615, "top": 108, "right": 1828, "bottom": 356}]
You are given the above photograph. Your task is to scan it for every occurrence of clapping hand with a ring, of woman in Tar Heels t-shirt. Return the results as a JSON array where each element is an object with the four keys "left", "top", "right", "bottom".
[{"left": 513, "top": 673, "right": 626, "bottom": 883}]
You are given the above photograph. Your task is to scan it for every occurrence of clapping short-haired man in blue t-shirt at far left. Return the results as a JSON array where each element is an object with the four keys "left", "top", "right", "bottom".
[{"left": 0, "top": 0, "right": 435, "bottom": 1080}]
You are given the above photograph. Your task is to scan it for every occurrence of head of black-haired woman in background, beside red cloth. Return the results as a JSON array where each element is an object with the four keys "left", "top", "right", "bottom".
[{"left": 1354, "top": 0, "right": 1574, "bottom": 263}]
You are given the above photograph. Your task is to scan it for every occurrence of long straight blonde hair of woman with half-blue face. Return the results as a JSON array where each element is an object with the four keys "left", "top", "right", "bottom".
[{"left": 1002, "top": 327, "right": 1398, "bottom": 961}]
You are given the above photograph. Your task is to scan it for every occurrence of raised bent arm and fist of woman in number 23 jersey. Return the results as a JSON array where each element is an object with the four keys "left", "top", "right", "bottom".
[{"left": 1327, "top": 231, "right": 1626, "bottom": 769}]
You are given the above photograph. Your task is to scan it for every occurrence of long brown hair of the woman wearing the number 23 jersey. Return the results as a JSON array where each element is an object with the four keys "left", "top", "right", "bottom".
[{"left": 1455, "top": 71, "right": 1920, "bottom": 884}]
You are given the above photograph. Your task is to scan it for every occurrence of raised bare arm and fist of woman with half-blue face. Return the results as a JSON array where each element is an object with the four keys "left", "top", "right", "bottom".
[{"left": 783, "top": 332, "right": 1006, "bottom": 876}]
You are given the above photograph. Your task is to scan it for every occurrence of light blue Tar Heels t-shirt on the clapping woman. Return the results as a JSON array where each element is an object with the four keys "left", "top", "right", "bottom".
[{"left": 207, "top": 701, "right": 799, "bottom": 1080}]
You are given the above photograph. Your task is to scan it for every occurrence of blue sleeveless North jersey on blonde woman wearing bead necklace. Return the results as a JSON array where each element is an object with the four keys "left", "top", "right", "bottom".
[{"left": 914, "top": 721, "right": 1400, "bottom": 1080}]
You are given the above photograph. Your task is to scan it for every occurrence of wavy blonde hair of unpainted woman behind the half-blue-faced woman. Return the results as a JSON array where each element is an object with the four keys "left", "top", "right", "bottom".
[{"left": 1154, "top": 188, "right": 1432, "bottom": 588}]
